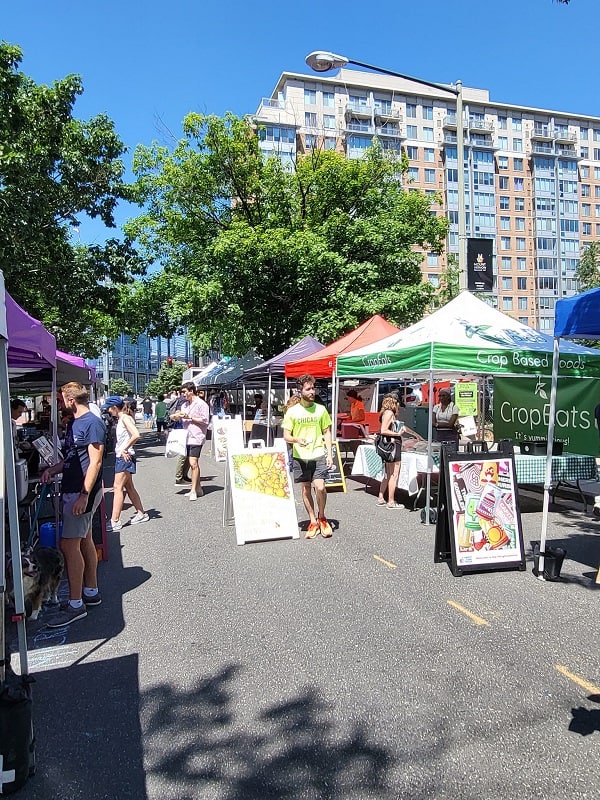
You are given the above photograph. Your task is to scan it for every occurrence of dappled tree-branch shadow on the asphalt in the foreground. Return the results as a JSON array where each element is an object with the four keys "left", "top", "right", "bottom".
[{"left": 141, "top": 664, "right": 394, "bottom": 800}]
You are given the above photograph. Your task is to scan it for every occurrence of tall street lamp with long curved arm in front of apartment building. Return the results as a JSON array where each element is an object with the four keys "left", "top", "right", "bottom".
[{"left": 305, "top": 50, "right": 467, "bottom": 291}]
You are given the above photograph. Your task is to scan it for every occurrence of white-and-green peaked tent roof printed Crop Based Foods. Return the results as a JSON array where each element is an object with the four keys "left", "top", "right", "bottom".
[{"left": 337, "top": 292, "right": 600, "bottom": 378}]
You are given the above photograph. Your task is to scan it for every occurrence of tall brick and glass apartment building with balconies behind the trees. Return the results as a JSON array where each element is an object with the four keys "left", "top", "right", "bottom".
[{"left": 253, "top": 69, "right": 600, "bottom": 332}]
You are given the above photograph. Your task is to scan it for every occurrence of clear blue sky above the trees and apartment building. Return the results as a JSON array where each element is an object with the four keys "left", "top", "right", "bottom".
[{"left": 0, "top": 0, "right": 600, "bottom": 242}]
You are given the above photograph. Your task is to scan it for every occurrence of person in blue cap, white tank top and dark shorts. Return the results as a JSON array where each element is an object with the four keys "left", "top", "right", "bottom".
[{"left": 102, "top": 395, "right": 150, "bottom": 533}]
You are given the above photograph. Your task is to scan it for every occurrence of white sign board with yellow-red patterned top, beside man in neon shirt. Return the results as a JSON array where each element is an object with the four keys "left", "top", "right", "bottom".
[{"left": 228, "top": 447, "right": 300, "bottom": 544}]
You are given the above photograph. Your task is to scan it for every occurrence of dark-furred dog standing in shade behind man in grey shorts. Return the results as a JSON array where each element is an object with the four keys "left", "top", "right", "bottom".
[{"left": 7, "top": 547, "right": 65, "bottom": 620}]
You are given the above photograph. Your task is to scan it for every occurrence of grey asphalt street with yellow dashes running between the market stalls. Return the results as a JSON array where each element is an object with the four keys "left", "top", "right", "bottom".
[{"left": 14, "top": 432, "right": 600, "bottom": 800}]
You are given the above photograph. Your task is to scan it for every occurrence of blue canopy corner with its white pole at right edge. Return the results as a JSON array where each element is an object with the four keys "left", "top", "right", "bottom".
[{"left": 538, "top": 288, "right": 600, "bottom": 580}]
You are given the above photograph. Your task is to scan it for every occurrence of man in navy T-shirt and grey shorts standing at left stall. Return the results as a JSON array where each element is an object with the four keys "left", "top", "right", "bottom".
[{"left": 40, "top": 383, "right": 106, "bottom": 628}]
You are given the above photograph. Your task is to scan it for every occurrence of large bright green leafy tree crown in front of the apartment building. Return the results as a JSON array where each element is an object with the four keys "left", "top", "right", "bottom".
[{"left": 126, "top": 114, "right": 447, "bottom": 357}]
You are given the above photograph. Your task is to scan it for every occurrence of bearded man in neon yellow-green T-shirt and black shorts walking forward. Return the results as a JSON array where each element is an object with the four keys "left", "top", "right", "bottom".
[{"left": 282, "top": 375, "right": 333, "bottom": 539}]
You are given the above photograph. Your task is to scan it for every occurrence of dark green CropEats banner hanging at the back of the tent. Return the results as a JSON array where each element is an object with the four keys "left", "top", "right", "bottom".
[{"left": 494, "top": 376, "right": 600, "bottom": 456}]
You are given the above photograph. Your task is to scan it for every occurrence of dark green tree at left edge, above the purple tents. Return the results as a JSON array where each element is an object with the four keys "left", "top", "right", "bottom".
[{"left": 0, "top": 42, "right": 146, "bottom": 356}]
